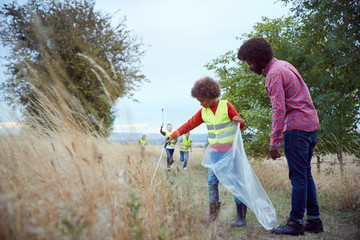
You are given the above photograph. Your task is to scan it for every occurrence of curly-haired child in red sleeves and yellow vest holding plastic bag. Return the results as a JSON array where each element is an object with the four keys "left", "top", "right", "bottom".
[{"left": 167, "top": 77, "right": 247, "bottom": 227}]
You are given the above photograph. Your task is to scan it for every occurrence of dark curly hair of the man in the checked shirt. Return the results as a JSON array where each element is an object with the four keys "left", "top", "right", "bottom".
[{"left": 238, "top": 37, "right": 274, "bottom": 63}]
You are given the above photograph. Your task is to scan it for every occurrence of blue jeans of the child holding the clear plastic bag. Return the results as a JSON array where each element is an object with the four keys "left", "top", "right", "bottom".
[{"left": 208, "top": 151, "right": 241, "bottom": 204}]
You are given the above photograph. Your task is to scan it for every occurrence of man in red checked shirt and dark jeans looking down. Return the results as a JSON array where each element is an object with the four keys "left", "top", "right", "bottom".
[{"left": 238, "top": 38, "right": 323, "bottom": 235}]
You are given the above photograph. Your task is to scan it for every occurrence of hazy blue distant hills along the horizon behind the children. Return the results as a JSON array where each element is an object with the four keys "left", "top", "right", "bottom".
[{"left": 108, "top": 133, "right": 207, "bottom": 147}]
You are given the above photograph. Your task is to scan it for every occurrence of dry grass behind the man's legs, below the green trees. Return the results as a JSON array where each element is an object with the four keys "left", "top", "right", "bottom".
[{"left": 252, "top": 156, "right": 360, "bottom": 214}]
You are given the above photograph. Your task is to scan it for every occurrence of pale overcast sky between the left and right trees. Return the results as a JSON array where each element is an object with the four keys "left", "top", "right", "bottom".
[{"left": 0, "top": 0, "right": 289, "bottom": 133}]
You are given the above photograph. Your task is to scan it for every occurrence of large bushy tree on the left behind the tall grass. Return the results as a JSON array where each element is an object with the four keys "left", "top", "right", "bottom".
[{"left": 0, "top": 0, "right": 146, "bottom": 134}]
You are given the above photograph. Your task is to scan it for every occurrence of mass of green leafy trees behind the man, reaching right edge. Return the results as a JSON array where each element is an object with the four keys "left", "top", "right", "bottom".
[{"left": 206, "top": 1, "right": 360, "bottom": 169}]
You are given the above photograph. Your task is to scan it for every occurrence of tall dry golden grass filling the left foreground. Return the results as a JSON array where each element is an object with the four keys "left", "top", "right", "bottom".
[{"left": 0, "top": 125, "right": 208, "bottom": 239}]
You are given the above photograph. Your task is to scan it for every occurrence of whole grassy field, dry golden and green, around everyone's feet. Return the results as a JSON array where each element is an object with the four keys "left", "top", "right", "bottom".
[{"left": 0, "top": 124, "right": 360, "bottom": 239}]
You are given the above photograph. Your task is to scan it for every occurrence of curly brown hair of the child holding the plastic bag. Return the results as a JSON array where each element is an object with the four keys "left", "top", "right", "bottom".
[{"left": 191, "top": 77, "right": 220, "bottom": 98}]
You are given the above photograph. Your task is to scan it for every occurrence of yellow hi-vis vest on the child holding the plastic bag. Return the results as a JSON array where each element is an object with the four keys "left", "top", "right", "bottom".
[{"left": 201, "top": 100, "right": 236, "bottom": 145}]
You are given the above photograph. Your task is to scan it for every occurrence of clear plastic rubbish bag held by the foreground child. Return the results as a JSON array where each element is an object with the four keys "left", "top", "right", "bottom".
[{"left": 201, "top": 122, "right": 279, "bottom": 230}]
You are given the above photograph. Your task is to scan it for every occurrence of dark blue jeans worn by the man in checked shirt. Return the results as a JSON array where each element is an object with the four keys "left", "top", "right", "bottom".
[{"left": 284, "top": 130, "right": 320, "bottom": 220}]
